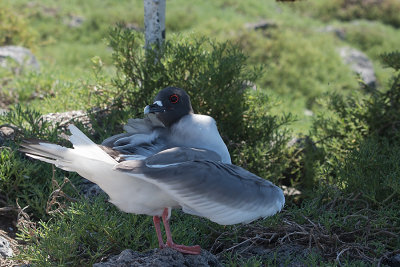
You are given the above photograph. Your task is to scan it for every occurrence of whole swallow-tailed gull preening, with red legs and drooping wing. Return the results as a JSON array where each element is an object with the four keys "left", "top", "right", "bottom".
[{"left": 21, "top": 87, "right": 285, "bottom": 254}]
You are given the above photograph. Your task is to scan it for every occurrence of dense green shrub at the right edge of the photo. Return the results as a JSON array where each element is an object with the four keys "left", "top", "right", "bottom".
[{"left": 311, "top": 52, "right": 400, "bottom": 202}]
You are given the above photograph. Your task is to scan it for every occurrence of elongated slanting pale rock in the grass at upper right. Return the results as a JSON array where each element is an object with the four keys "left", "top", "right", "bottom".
[{"left": 339, "top": 47, "right": 376, "bottom": 88}]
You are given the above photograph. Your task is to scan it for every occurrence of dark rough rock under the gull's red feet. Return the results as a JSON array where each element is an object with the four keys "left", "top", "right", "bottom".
[{"left": 93, "top": 248, "right": 222, "bottom": 267}]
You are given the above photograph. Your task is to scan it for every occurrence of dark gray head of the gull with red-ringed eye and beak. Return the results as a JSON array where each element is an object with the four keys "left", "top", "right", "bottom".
[{"left": 144, "top": 87, "right": 193, "bottom": 127}]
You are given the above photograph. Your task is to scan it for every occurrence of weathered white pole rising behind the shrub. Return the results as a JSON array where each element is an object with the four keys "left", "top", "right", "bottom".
[{"left": 144, "top": 0, "right": 165, "bottom": 49}]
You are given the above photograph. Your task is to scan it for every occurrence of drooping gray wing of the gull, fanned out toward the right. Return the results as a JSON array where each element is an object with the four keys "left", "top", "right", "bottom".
[{"left": 115, "top": 148, "right": 285, "bottom": 225}]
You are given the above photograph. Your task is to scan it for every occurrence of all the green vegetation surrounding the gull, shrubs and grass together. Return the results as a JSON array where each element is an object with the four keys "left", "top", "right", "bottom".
[{"left": 0, "top": 0, "right": 400, "bottom": 266}]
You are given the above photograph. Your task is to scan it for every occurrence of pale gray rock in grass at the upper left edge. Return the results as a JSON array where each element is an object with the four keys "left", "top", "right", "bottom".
[{"left": 0, "top": 45, "right": 40, "bottom": 74}]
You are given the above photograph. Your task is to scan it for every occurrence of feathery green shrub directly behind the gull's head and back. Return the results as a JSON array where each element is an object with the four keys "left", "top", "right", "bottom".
[{"left": 98, "top": 28, "right": 293, "bottom": 181}]
